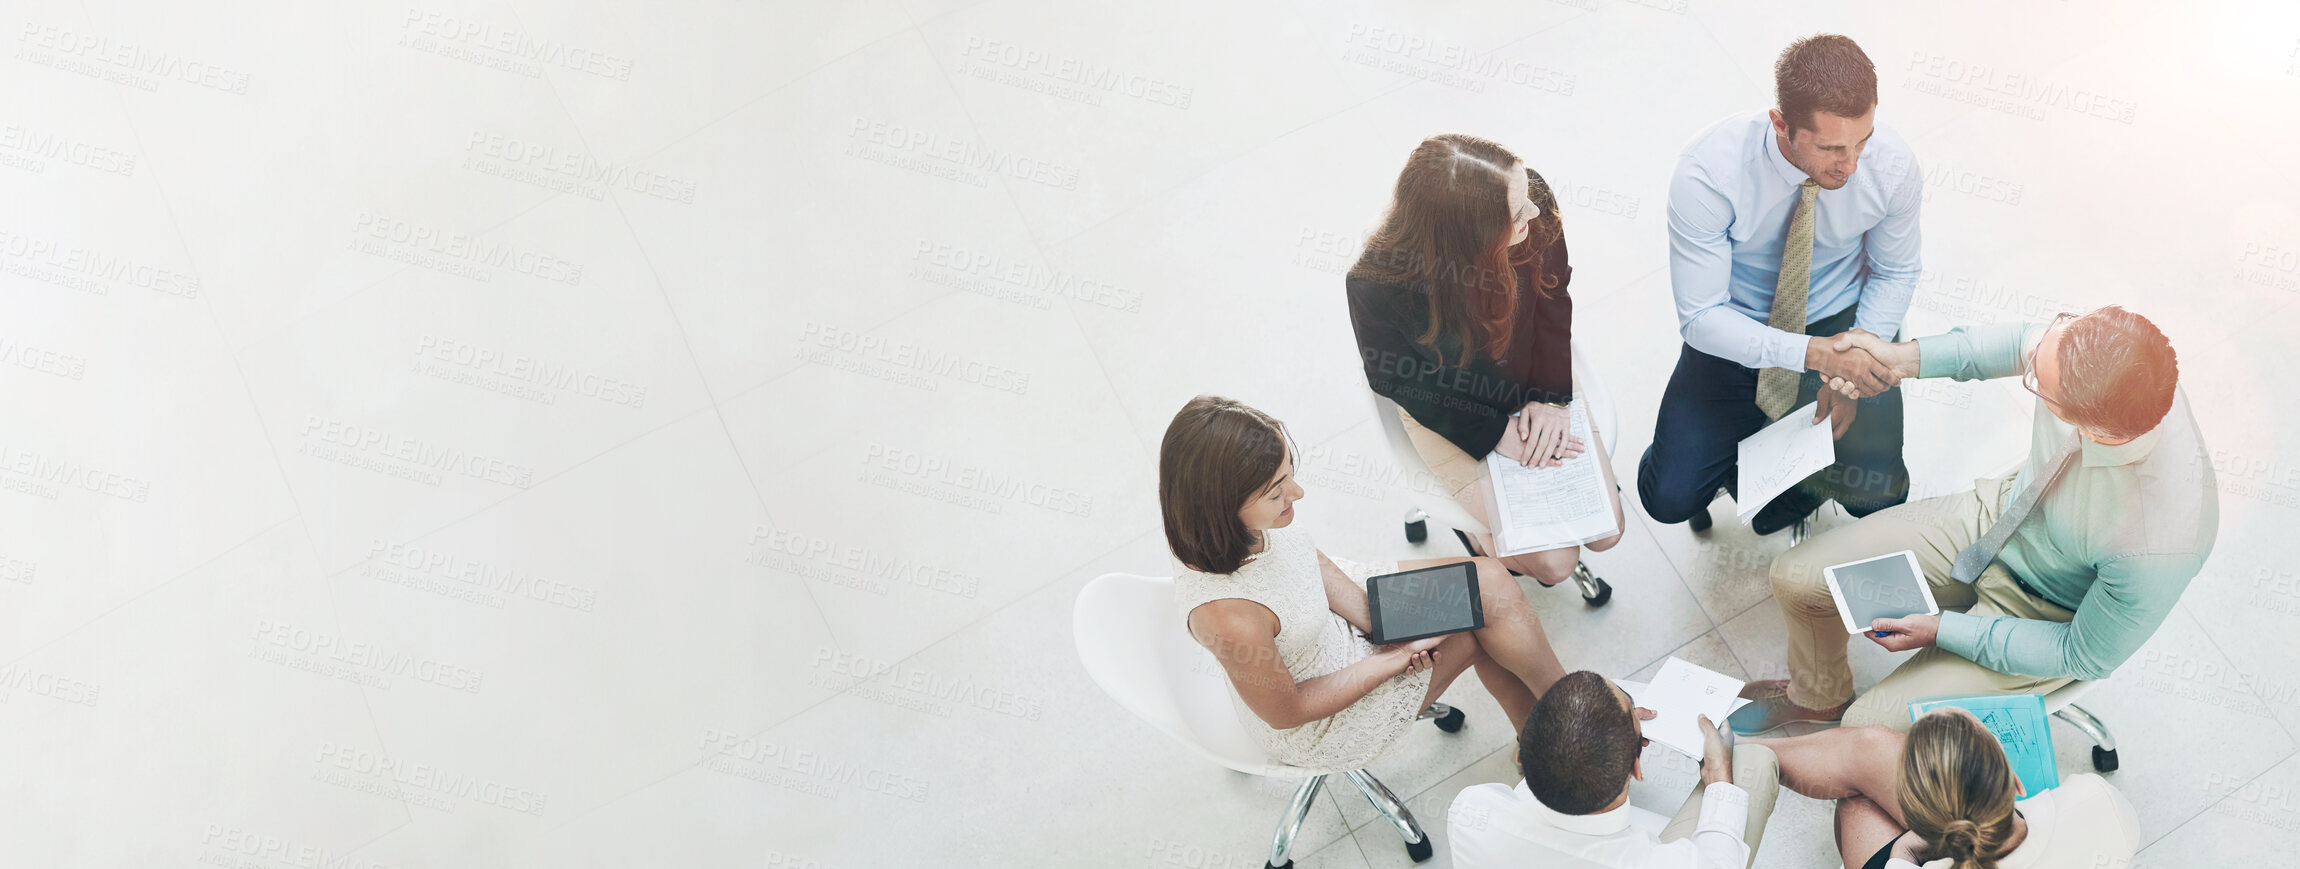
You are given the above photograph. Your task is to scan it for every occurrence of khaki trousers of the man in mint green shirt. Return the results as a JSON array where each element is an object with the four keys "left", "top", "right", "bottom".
[{"left": 1771, "top": 474, "right": 2075, "bottom": 731}]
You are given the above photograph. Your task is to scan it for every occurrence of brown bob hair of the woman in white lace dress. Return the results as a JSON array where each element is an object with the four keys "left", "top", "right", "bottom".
[{"left": 1157, "top": 395, "right": 1293, "bottom": 572}]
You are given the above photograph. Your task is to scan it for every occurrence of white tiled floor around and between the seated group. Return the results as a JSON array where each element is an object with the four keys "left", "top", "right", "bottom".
[{"left": 0, "top": 0, "right": 2300, "bottom": 869}]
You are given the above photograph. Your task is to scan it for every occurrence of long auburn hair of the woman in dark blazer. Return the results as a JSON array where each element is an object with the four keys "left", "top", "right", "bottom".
[{"left": 1350, "top": 133, "right": 1564, "bottom": 363}]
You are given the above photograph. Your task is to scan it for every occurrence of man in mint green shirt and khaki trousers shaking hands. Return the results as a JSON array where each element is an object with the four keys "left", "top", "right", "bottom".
[{"left": 1732, "top": 306, "right": 2220, "bottom": 733}]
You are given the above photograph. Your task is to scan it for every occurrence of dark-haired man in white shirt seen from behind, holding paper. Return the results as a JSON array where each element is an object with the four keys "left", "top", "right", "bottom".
[{"left": 1447, "top": 669, "right": 1780, "bottom": 869}]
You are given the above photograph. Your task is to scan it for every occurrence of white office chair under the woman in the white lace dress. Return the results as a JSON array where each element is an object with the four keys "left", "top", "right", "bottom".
[{"left": 1072, "top": 572, "right": 1465, "bottom": 869}]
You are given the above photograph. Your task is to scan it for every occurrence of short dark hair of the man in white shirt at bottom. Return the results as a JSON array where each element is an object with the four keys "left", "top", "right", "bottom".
[{"left": 1518, "top": 669, "right": 1642, "bottom": 814}]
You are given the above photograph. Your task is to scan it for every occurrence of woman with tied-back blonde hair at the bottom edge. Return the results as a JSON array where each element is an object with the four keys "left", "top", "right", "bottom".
[{"left": 1743, "top": 706, "right": 2139, "bottom": 869}]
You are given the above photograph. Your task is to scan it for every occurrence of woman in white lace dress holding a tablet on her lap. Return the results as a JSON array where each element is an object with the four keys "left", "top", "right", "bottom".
[{"left": 1159, "top": 395, "right": 1564, "bottom": 770}]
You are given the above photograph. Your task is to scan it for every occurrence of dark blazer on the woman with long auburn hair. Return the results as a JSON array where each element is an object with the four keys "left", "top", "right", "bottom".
[{"left": 1346, "top": 170, "right": 1573, "bottom": 457}]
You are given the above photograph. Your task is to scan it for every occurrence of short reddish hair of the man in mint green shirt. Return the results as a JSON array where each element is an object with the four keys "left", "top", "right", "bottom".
[{"left": 2054, "top": 306, "right": 2180, "bottom": 437}]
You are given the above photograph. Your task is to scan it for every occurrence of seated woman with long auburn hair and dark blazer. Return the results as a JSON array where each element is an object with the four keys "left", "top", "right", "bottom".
[{"left": 1346, "top": 133, "right": 1624, "bottom": 586}]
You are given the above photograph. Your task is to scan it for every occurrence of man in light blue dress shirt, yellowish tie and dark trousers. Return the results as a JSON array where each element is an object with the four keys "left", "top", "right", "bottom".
[{"left": 1638, "top": 34, "right": 1923, "bottom": 533}]
